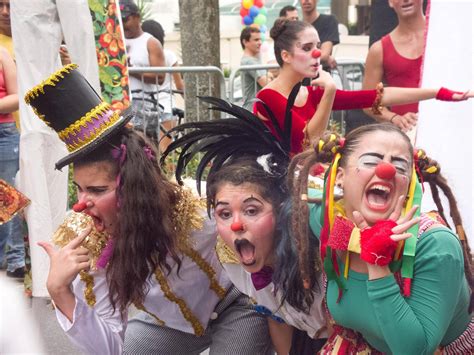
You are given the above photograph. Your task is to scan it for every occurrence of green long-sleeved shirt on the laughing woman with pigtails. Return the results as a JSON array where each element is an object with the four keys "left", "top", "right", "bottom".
[{"left": 310, "top": 199, "right": 471, "bottom": 354}]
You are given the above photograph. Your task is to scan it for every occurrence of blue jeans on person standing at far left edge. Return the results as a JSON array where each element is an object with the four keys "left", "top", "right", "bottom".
[{"left": 0, "top": 123, "right": 25, "bottom": 271}]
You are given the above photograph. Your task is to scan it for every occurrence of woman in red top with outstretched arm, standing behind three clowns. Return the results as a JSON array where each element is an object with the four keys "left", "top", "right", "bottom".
[{"left": 254, "top": 19, "right": 474, "bottom": 153}]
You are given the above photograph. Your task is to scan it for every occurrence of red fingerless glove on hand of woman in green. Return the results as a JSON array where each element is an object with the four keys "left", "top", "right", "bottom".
[{"left": 360, "top": 220, "right": 397, "bottom": 266}]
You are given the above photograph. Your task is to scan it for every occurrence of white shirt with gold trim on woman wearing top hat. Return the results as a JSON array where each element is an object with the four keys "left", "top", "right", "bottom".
[{"left": 56, "top": 211, "right": 231, "bottom": 354}]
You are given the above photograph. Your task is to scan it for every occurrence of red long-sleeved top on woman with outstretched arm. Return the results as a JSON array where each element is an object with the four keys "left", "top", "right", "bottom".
[{"left": 253, "top": 86, "right": 377, "bottom": 154}]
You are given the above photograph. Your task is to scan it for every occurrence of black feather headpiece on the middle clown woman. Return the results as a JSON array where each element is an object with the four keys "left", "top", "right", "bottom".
[{"left": 161, "top": 84, "right": 301, "bottom": 194}]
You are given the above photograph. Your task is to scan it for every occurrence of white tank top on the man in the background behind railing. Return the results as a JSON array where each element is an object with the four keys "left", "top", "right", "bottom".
[{"left": 125, "top": 32, "right": 157, "bottom": 94}]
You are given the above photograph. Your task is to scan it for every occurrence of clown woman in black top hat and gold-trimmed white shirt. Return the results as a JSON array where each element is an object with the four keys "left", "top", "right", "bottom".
[{"left": 25, "top": 65, "right": 270, "bottom": 355}]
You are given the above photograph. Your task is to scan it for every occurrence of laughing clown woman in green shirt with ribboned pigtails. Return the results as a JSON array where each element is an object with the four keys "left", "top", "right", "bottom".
[{"left": 289, "top": 124, "right": 474, "bottom": 354}]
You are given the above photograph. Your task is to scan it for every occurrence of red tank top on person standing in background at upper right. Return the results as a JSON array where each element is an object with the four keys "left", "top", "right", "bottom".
[{"left": 382, "top": 35, "right": 423, "bottom": 115}]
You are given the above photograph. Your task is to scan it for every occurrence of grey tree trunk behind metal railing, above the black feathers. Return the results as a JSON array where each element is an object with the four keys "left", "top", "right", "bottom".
[{"left": 179, "top": 0, "right": 220, "bottom": 122}]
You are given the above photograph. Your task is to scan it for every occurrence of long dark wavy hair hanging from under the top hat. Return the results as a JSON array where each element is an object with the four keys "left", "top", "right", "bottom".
[{"left": 74, "top": 128, "right": 181, "bottom": 311}]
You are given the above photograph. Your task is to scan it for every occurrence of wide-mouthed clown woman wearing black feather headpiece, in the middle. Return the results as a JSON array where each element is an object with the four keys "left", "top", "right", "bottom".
[{"left": 162, "top": 85, "right": 327, "bottom": 354}]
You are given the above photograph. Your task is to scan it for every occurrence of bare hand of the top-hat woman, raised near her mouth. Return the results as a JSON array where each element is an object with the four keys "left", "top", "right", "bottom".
[{"left": 38, "top": 227, "right": 91, "bottom": 298}]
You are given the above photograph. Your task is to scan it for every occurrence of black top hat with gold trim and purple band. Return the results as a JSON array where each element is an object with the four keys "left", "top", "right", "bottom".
[{"left": 25, "top": 64, "right": 133, "bottom": 169}]
